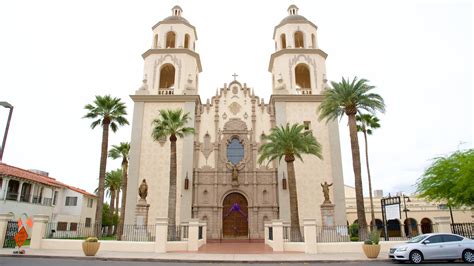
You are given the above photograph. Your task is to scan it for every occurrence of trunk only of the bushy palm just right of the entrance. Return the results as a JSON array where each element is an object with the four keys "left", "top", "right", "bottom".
[{"left": 285, "top": 156, "right": 302, "bottom": 242}]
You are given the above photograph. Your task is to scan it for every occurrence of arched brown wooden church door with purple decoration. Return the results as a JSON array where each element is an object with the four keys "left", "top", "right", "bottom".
[{"left": 222, "top": 192, "right": 249, "bottom": 239}]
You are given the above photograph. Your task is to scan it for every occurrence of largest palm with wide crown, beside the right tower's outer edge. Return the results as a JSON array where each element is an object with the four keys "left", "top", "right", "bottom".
[{"left": 318, "top": 77, "right": 385, "bottom": 239}]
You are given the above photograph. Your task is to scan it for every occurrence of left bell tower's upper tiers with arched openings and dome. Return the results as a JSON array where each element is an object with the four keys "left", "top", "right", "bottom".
[{"left": 137, "top": 6, "right": 202, "bottom": 95}]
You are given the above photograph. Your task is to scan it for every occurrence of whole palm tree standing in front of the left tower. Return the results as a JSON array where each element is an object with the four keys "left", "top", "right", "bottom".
[{"left": 152, "top": 109, "right": 194, "bottom": 239}]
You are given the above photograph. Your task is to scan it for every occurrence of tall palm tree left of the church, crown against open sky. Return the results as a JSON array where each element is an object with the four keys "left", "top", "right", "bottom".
[{"left": 83, "top": 95, "right": 128, "bottom": 236}]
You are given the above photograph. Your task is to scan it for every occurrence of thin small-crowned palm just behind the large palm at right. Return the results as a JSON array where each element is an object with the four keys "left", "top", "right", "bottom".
[{"left": 356, "top": 114, "right": 380, "bottom": 229}]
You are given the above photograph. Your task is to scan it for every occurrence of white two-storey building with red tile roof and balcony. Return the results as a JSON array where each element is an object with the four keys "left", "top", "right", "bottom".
[{"left": 0, "top": 163, "right": 97, "bottom": 231}]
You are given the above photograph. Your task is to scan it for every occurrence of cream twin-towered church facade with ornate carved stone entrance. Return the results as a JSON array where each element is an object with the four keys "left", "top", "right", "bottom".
[{"left": 125, "top": 5, "right": 346, "bottom": 239}]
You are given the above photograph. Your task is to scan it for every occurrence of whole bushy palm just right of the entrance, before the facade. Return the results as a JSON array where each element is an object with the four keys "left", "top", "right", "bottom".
[{"left": 258, "top": 124, "right": 322, "bottom": 240}]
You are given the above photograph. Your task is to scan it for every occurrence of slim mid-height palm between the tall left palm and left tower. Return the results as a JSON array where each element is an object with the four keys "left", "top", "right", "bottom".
[{"left": 109, "top": 142, "right": 130, "bottom": 240}]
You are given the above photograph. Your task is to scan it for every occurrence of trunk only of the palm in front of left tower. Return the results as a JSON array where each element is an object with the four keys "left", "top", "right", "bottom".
[{"left": 168, "top": 135, "right": 177, "bottom": 240}]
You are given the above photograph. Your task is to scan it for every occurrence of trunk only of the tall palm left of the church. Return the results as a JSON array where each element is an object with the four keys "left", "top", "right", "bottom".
[{"left": 95, "top": 121, "right": 110, "bottom": 237}]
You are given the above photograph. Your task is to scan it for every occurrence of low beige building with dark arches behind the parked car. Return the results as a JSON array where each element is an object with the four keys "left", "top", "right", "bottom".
[{"left": 344, "top": 185, "right": 474, "bottom": 237}]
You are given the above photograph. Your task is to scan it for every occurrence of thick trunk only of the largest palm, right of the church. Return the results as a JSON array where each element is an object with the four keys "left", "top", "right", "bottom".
[{"left": 347, "top": 113, "right": 367, "bottom": 240}]
